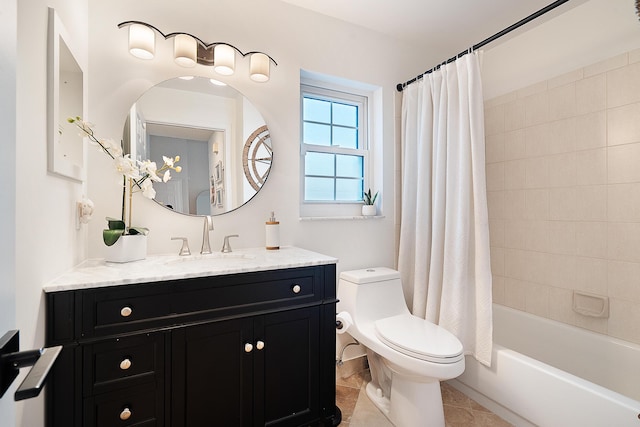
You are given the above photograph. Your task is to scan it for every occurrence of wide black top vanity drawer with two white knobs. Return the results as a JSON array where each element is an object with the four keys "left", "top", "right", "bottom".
[{"left": 81, "top": 267, "right": 324, "bottom": 338}]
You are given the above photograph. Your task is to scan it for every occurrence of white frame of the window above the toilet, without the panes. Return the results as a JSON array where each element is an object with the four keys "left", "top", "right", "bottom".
[{"left": 300, "top": 79, "right": 371, "bottom": 217}]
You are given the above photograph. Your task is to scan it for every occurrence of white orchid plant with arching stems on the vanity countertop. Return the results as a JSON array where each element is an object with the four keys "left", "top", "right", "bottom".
[{"left": 67, "top": 117, "right": 182, "bottom": 246}]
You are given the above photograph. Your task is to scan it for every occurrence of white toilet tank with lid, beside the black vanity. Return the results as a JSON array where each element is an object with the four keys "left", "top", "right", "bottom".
[{"left": 338, "top": 267, "right": 409, "bottom": 323}]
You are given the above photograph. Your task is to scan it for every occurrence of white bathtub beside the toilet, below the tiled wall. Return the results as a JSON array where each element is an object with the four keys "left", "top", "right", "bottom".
[{"left": 449, "top": 304, "right": 640, "bottom": 427}]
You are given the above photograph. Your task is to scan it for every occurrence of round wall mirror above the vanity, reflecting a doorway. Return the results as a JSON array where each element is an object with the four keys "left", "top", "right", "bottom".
[{"left": 123, "top": 77, "right": 273, "bottom": 215}]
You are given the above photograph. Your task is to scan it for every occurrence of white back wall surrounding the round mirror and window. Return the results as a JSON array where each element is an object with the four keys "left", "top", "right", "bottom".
[{"left": 89, "top": 0, "right": 423, "bottom": 270}]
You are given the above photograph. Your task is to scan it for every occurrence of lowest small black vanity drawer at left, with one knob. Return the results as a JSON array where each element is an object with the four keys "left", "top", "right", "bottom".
[{"left": 83, "top": 386, "right": 164, "bottom": 427}]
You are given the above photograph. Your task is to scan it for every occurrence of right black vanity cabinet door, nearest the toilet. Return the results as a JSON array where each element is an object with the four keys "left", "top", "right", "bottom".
[{"left": 254, "top": 306, "right": 320, "bottom": 426}]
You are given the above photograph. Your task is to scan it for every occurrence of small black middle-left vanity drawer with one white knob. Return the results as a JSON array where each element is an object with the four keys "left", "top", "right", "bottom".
[{"left": 83, "top": 332, "right": 164, "bottom": 396}]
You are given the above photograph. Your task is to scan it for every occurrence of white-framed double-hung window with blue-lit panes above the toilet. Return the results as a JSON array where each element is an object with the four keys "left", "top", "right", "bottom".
[{"left": 301, "top": 84, "right": 369, "bottom": 204}]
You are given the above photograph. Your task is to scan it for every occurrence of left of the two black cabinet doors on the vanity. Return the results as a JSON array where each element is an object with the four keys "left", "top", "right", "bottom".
[{"left": 171, "top": 318, "right": 253, "bottom": 427}]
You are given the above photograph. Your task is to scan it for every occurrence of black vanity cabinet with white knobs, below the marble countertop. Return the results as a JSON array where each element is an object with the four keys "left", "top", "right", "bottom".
[{"left": 46, "top": 264, "right": 339, "bottom": 427}]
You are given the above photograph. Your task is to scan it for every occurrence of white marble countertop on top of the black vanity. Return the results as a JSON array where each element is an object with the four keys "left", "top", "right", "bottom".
[{"left": 43, "top": 246, "right": 338, "bottom": 292}]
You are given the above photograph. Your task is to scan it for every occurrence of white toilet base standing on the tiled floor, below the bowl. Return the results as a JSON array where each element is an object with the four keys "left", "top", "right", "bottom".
[{"left": 366, "top": 375, "right": 444, "bottom": 427}]
